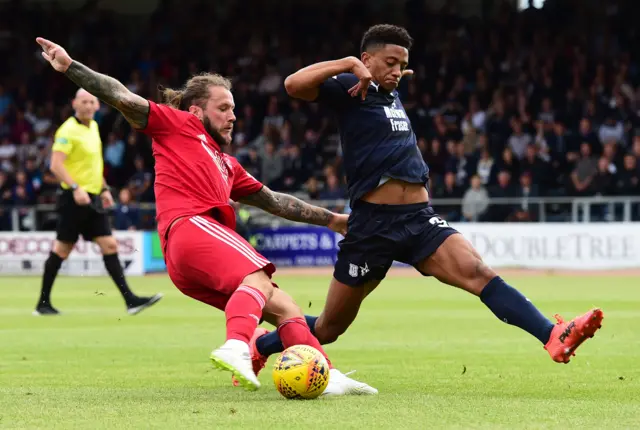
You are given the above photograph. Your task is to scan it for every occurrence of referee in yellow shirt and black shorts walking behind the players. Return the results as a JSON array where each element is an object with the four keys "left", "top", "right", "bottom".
[{"left": 33, "top": 89, "right": 162, "bottom": 315}]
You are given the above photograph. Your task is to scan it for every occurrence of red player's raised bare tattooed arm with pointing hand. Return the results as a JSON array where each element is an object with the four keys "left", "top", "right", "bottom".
[{"left": 36, "top": 37, "right": 149, "bottom": 129}]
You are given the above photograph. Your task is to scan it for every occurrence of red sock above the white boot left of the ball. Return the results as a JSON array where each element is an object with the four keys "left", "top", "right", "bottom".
[{"left": 224, "top": 285, "right": 267, "bottom": 343}]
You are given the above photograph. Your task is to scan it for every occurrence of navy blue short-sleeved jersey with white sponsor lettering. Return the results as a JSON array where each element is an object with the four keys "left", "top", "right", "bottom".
[{"left": 317, "top": 73, "right": 429, "bottom": 204}]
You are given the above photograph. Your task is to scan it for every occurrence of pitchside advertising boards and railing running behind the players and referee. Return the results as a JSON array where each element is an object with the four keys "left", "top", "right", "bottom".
[{"left": 0, "top": 197, "right": 640, "bottom": 276}]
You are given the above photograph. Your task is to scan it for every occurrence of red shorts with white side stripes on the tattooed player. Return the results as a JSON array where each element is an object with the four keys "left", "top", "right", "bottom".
[{"left": 165, "top": 216, "right": 276, "bottom": 310}]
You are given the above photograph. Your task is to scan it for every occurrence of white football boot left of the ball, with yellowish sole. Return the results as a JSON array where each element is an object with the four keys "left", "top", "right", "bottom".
[{"left": 211, "top": 339, "right": 260, "bottom": 391}]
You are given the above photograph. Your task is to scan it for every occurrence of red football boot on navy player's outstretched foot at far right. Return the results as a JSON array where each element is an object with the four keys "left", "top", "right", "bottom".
[{"left": 544, "top": 309, "right": 604, "bottom": 363}]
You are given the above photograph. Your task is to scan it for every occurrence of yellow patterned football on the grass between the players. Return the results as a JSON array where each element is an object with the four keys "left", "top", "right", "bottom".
[{"left": 273, "top": 345, "right": 329, "bottom": 399}]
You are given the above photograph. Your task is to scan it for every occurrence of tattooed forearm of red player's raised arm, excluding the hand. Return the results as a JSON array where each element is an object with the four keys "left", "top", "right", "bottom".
[{"left": 65, "top": 61, "right": 149, "bottom": 128}]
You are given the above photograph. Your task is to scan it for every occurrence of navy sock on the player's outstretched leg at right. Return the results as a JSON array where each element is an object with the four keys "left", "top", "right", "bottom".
[{"left": 480, "top": 276, "right": 553, "bottom": 344}]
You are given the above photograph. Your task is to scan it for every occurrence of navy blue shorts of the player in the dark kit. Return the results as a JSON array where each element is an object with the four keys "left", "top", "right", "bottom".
[{"left": 333, "top": 200, "right": 458, "bottom": 287}]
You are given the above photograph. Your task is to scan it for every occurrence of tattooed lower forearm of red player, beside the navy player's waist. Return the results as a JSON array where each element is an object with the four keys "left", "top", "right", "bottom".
[{"left": 240, "top": 187, "right": 333, "bottom": 226}]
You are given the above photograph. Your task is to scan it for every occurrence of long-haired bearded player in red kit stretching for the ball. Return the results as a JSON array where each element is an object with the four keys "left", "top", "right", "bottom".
[{"left": 37, "top": 38, "right": 377, "bottom": 395}]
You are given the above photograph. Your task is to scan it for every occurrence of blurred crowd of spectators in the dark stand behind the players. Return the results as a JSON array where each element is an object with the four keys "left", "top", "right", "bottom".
[{"left": 0, "top": 0, "right": 640, "bottom": 230}]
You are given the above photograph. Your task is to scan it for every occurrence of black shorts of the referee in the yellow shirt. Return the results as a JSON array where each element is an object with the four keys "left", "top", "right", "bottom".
[{"left": 56, "top": 190, "right": 112, "bottom": 243}]
